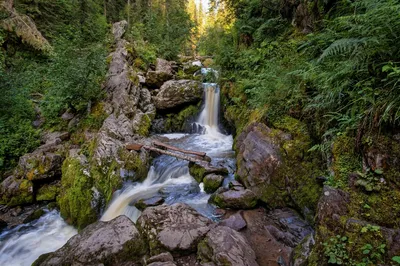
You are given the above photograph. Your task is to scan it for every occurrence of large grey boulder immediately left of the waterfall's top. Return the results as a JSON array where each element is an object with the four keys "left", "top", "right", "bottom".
[{"left": 154, "top": 80, "right": 203, "bottom": 110}]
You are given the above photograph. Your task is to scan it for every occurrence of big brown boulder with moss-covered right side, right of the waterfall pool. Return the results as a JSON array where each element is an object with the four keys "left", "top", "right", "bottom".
[{"left": 236, "top": 117, "right": 323, "bottom": 222}]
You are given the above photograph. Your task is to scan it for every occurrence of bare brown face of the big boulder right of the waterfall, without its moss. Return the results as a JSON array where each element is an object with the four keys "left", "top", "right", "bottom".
[{"left": 237, "top": 123, "right": 282, "bottom": 187}]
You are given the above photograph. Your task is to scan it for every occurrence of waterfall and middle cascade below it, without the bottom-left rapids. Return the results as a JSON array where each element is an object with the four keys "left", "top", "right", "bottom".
[{"left": 101, "top": 68, "right": 234, "bottom": 221}]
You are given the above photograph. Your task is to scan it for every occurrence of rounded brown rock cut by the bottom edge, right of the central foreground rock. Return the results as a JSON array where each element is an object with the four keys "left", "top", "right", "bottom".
[{"left": 197, "top": 226, "right": 258, "bottom": 266}]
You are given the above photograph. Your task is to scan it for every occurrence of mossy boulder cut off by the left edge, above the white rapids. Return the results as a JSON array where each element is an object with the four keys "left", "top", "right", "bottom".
[{"left": 0, "top": 176, "right": 34, "bottom": 207}]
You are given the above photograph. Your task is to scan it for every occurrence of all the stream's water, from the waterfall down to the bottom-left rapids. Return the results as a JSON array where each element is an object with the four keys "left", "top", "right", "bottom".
[{"left": 0, "top": 66, "right": 235, "bottom": 266}]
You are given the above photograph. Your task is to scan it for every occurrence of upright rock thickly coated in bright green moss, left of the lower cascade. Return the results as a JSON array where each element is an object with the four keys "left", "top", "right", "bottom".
[{"left": 57, "top": 158, "right": 97, "bottom": 229}]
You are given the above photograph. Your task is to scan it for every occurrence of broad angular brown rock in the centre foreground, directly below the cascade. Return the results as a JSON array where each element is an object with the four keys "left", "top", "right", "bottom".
[{"left": 137, "top": 203, "right": 212, "bottom": 255}]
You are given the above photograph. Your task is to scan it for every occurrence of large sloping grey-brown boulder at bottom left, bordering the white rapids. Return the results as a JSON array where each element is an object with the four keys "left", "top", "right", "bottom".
[{"left": 33, "top": 216, "right": 148, "bottom": 266}]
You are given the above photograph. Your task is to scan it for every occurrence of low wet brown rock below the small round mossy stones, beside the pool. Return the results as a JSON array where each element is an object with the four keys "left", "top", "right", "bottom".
[{"left": 209, "top": 188, "right": 258, "bottom": 209}]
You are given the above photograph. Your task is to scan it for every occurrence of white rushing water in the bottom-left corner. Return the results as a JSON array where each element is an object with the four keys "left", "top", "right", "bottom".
[{"left": 0, "top": 211, "right": 77, "bottom": 266}]
